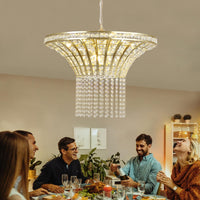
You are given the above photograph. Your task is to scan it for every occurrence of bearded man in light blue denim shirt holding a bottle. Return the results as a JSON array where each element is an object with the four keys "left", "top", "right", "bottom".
[{"left": 111, "top": 134, "right": 161, "bottom": 194}]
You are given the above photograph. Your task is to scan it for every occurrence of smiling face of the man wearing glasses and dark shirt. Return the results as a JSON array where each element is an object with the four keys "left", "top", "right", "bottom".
[{"left": 61, "top": 142, "right": 78, "bottom": 163}]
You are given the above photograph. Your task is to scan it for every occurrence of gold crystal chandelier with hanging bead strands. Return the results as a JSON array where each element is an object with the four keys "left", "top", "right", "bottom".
[{"left": 44, "top": 0, "right": 157, "bottom": 118}]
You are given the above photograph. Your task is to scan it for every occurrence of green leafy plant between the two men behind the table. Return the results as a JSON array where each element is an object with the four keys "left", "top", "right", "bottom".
[{"left": 79, "top": 148, "right": 109, "bottom": 181}]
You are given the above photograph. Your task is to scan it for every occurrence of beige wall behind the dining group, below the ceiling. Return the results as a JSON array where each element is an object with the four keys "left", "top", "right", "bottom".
[{"left": 0, "top": 75, "right": 200, "bottom": 173}]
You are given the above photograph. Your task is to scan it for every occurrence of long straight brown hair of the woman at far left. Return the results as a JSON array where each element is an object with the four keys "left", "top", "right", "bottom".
[{"left": 0, "top": 131, "right": 29, "bottom": 200}]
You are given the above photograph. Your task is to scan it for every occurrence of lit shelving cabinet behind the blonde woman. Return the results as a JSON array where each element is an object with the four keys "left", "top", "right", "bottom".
[{"left": 164, "top": 123, "right": 199, "bottom": 176}]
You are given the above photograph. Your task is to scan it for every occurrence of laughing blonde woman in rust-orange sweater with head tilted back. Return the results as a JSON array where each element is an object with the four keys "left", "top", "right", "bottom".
[{"left": 157, "top": 138, "right": 200, "bottom": 200}]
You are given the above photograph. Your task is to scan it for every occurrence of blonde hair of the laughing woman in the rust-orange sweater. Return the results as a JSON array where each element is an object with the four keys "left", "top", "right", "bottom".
[{"left": 186, "top": 138, "right": 200, "bottom": 165}]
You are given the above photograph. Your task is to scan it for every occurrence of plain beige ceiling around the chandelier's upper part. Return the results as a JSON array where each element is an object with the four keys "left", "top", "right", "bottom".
[{"left": 0, "top": 0, "right": 200, "bottom": 91}]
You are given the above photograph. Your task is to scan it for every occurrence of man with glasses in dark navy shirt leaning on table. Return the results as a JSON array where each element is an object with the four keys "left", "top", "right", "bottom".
[{"left": 33, "top": 137, "right": 87, "bottom": 192}]
